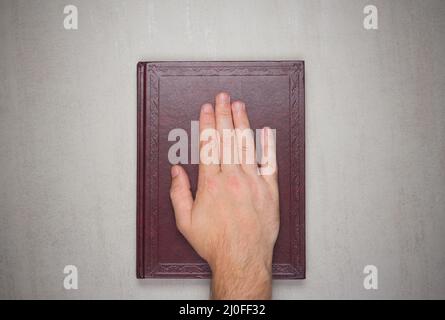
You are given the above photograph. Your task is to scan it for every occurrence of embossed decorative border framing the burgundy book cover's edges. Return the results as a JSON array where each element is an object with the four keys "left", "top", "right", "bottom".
[{"left": 136, "top": 61, "right": 305, "bottom": 279}]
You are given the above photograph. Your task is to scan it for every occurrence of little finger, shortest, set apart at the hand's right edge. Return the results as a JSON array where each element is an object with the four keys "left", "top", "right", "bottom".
[{"left": 259, "top": 127, "right": 278, "bottom": 188}]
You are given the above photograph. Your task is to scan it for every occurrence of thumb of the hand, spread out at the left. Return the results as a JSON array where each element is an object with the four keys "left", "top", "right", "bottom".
[{"left": 170, "top": 166, "right": 193, "bottom": 234}]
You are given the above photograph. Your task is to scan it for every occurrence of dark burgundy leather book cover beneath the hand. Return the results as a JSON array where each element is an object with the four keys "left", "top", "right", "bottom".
[{"left": 136, "top": 61, "right": 305, "bottom": 279}]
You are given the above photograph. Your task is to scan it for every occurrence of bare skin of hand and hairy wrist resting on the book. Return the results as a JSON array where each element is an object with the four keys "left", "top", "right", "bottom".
[{"left": 170, "top": 92, "right": 279, "bottom": 299}]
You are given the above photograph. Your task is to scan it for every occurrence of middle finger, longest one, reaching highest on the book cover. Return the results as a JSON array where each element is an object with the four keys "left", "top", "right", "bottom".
[{"left": 215, "top": 92, "right": 239, "bottom": 171}]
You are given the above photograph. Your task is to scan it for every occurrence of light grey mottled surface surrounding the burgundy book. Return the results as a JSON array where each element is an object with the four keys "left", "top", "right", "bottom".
[{"left": 0, "top": 0, "right": 445, "bottom": 299}]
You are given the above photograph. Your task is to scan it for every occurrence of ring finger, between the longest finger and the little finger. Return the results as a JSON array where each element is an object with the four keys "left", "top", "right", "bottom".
[{"left": 232, "top": 101, "right": 258, "bottom": 176}]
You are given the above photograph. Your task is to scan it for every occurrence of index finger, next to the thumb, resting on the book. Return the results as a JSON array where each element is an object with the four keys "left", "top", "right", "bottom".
[{"left": 199, "top": 103, "right": 221, "bottom": 179}]
